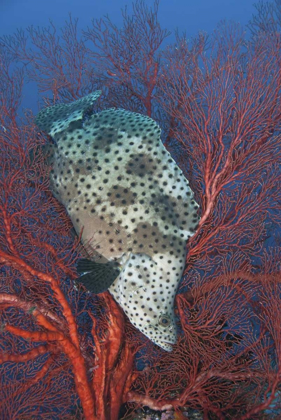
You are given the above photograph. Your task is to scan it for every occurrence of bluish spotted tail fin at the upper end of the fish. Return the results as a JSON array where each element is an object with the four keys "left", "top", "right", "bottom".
[{"left": 35, "top": 90, "right": 102, "bottom": 137}]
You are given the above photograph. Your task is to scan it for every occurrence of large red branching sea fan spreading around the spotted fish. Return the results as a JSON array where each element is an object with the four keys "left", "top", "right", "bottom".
[{"left": 0, "top": 1, "right": 281, "bottom": 420}]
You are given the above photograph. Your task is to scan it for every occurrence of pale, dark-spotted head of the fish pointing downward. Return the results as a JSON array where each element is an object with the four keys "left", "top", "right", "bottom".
[{"left": 110, "top": 254, "right": 177, "bottom": 351}]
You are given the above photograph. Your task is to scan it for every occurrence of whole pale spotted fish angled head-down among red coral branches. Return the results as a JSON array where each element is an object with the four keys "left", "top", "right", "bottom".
[{"left": 36, "top": 91, "right": 198, "bottom": 351}]
